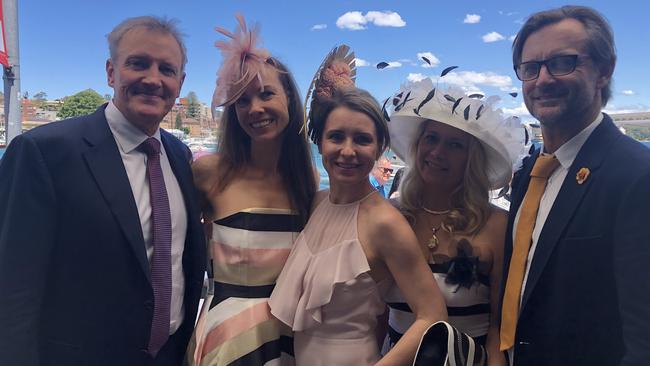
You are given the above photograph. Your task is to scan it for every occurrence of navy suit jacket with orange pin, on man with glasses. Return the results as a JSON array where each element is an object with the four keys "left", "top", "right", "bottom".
[{"left": 504, "top": 115, "right": 650, "bottom": 366}]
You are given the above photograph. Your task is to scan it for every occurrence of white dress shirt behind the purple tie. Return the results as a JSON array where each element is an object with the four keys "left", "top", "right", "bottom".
[{"left": 105, "top": 101, "right": 187, "bottom": 334}]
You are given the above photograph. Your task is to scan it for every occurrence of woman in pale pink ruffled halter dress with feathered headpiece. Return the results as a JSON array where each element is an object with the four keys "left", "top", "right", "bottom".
[{"left": 269, "top": 46, "right": 446, "bottom": 366}]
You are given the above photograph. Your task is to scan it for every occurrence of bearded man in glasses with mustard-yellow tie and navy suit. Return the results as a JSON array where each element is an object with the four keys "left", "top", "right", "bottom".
[{"left": 501, "top": 6, "right": 650, "bottom": 366}]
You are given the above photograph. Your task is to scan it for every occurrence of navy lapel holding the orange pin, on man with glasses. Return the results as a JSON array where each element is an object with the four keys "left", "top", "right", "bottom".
[{"left": 521, "top": 115, "right": 620, "bottom": 309}]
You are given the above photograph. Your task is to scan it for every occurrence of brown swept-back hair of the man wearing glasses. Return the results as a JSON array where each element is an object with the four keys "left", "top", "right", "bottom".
[{"left": 512, "top": 5, "right": 616, "bottom": 106}]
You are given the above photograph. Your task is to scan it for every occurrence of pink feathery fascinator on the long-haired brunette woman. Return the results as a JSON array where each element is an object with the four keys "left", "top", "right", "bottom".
[{"left": 212, "top": 14, "right": 270, "bottom": 110}]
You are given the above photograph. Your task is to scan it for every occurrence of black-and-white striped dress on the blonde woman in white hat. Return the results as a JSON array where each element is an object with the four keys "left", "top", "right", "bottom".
[{"left": 382, "top": 262, "right": 490, "bottom": 354}]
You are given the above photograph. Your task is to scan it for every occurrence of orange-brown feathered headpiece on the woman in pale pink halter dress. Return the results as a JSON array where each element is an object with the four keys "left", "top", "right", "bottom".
[{"left": 303, "top": 44, "right": 357, "bottom": 135}]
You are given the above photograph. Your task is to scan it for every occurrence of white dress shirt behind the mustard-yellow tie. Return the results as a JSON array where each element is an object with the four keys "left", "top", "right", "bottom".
[{"left": 508, "top": 113, "right": 603, "bottom": 365}]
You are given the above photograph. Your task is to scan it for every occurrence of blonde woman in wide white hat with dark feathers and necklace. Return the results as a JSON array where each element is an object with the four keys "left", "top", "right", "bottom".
[{"left": 387, "top": 79, "right": 524, "bottom": 366}]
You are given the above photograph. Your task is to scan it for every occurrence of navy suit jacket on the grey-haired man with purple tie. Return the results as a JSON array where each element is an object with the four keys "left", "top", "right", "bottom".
[{"left": 0, "top": 106, "right": 205, "bottom": 366}]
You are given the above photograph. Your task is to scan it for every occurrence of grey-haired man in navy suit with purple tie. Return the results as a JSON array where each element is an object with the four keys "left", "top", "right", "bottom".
[{"left": 0, "top": 17, "right": 205, "bottom": 366}]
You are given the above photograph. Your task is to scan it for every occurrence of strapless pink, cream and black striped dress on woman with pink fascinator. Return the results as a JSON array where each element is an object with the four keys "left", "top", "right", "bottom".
[{"left": 186, "top": 208, "right": 302, "bottom": 366}]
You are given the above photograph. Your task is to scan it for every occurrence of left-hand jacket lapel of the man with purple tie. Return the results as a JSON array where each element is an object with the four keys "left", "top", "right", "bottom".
[{"left": 84, "top": 108, "right": 151, "bottom": 281}]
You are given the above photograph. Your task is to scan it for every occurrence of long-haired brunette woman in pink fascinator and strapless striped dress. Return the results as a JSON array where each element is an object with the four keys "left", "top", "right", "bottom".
[{"left": 187, "top": 16, "right": 317, "bottom": 366}]
